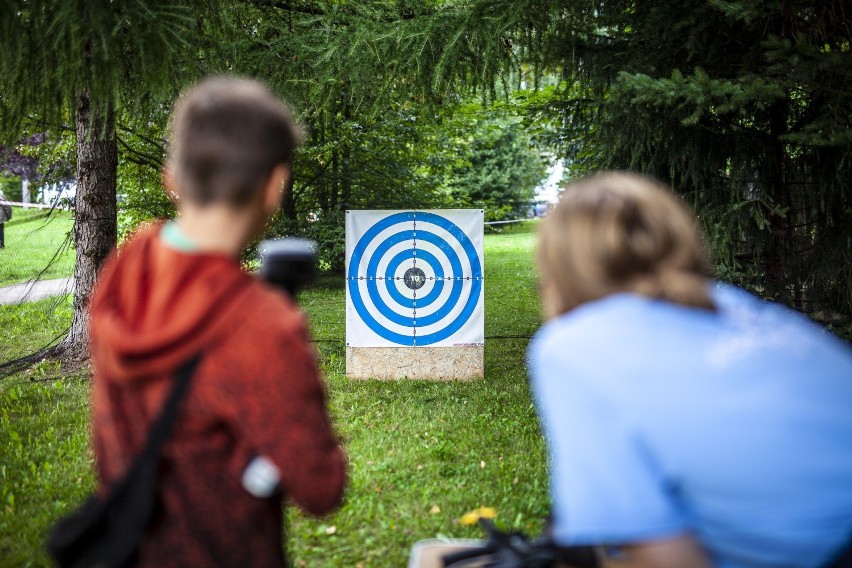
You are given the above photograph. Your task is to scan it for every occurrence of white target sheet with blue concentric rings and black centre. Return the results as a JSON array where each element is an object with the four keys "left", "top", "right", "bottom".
[{"left": 346, "top": 209, "right": 485, "bottom": 347}]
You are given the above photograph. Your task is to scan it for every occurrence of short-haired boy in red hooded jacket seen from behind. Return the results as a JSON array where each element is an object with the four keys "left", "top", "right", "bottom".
[{"left": 91, "top": 78, "right": 345, "bottom": 567}]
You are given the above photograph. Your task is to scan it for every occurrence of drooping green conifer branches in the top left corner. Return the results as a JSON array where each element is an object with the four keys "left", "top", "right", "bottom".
[{"left": 0, "top": 0, "right": 217, "bottom": 134}]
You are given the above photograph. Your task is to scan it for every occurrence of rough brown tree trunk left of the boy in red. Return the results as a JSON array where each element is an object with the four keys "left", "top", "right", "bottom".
[{"left": 59, "top": 91, "right": 118, "bottom": 360}]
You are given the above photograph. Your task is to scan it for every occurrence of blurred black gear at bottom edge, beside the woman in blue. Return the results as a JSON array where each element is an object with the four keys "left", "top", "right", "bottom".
[{"left": 443, "top": 518, "right": 600, "bottom": 568}]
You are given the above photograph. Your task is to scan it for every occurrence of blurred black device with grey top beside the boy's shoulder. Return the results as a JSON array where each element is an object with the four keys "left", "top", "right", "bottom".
[{"left": 258, "top": 237, "right": 317, "bottom": 298}]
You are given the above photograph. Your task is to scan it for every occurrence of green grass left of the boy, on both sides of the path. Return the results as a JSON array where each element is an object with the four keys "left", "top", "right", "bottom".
[{"left": 0, "top": 297, "right": 94, "bottom": 566}]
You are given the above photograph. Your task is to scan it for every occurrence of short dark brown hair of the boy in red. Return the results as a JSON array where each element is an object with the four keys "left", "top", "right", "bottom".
[{"left": 168, "top": 77, "right": 302, "bottom": 206}]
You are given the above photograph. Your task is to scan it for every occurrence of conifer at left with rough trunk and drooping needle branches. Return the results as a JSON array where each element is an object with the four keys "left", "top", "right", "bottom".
[{"left": 0, "top": 0, "right": 216, "bottom": 359}]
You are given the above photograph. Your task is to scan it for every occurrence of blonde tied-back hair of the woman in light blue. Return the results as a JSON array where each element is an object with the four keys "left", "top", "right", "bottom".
[{"left": 537, "top": 172, "right": 715, "bottom": 315}]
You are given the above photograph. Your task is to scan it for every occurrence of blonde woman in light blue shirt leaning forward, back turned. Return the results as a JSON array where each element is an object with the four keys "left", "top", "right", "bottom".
[{"left": 529, "top": 173, "right": 852, "bottom": 567}]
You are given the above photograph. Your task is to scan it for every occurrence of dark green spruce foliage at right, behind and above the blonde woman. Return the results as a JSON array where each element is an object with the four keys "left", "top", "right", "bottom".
[{"left": 528, "top": 0, "right": 852, "bottom": 333}]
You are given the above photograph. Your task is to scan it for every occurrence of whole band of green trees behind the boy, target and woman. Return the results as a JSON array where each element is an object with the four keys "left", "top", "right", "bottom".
[{"left": 0, "top": 0, "right": 852, "bottom": 364}]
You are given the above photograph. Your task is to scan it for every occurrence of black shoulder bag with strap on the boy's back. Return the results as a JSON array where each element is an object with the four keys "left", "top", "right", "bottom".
[{"left": 47, "top": 357, "right": 199, "bottom": 568}]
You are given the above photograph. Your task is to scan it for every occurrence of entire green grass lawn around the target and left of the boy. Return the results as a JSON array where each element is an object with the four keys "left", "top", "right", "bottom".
[{"left": 0, "top": 220, "right": 548, "bottom": 567}]
